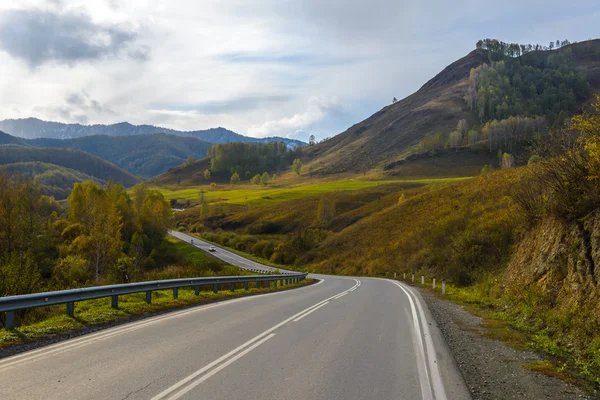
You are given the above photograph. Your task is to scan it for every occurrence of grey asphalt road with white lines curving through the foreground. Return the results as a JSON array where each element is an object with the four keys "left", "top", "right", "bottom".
[{"left": 0, "top": 233, "right": 470, "bottom": 400}]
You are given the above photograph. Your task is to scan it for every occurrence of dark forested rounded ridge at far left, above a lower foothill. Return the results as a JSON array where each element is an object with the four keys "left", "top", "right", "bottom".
[{"left": 0, "top": 145, "right": 139, "bottom": 186}]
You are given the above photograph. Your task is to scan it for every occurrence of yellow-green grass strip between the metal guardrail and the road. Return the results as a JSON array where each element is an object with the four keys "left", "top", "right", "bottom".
[{"left": 0, "top": 279, "right": 313, "bottom": 355}]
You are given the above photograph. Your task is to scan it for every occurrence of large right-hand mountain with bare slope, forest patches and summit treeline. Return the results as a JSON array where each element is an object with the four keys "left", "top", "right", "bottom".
[{"left": 304, "top": 39, "right": 600, "bottom": 174}]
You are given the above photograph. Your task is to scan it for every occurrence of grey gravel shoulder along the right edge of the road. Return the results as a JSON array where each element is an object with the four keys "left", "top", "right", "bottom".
[{"left": 421, "top": 290, "right": 596, "bottom": 400}]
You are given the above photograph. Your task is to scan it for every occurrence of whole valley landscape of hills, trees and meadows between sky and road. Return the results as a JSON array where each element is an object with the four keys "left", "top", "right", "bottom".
[{"left": 0, "top": 39, "right": 600, "bottom": 395}]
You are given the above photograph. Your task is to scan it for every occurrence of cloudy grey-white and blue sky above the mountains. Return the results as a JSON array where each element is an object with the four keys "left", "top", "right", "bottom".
[{"left": 0, "top": 0, "right": 600, "bottom": 140}]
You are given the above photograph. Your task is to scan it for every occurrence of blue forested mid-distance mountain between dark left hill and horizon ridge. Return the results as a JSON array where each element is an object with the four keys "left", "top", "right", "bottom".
[{"left": 29, "top": 133, "right": 212, "bottom": 178}]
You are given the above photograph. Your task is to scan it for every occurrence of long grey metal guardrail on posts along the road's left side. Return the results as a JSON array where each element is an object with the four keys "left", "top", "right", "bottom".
[{"left": 0, "top": 273, "right": 308, "bottom": 329}]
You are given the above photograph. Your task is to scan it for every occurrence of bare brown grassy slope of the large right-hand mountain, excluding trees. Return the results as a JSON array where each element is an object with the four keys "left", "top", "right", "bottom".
[{"left": 304, "top": 40, "right": 600, "bottom": 174}]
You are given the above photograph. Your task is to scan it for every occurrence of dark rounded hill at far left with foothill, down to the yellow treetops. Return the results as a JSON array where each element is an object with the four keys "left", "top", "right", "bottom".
[{"left": 0, "top": 144, "right": 139, "bottom": 194}]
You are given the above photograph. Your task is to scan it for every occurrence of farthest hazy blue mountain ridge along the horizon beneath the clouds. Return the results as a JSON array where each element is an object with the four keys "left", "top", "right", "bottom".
[{"left": 0, "top": 118, "right": 305, "bottom": 147}]
